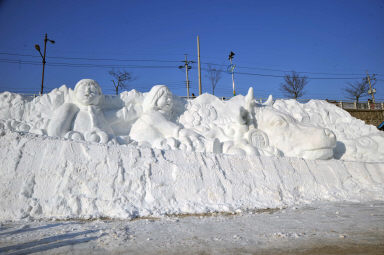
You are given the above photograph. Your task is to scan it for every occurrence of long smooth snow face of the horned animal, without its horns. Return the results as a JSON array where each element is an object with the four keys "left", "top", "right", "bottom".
[{"left": 257, "top": 107, "right": 336, "bottom": 159}]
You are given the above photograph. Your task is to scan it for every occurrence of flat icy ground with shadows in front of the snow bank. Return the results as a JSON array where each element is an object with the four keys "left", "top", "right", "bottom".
[{"left": 0, "top": 201, "right": 384, "bottom": 254}]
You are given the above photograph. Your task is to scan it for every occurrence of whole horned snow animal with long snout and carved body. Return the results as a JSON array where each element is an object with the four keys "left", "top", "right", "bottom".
[{"left": 180, "top": 88, "right": 336, "bottom": 159}]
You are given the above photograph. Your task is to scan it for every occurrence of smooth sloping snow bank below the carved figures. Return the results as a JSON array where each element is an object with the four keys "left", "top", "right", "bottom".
[{"left": 0, "top": 131, "right": 384, "bottom": 220}]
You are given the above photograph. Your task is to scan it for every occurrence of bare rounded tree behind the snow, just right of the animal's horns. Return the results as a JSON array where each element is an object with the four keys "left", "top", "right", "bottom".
[{"left": 280, "top": 71, "right": 308, "bottom": 99}]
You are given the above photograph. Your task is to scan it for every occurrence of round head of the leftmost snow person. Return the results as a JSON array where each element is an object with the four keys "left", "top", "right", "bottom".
[{"left": 75, "top": 79, "right": 103, "bottom": 106}]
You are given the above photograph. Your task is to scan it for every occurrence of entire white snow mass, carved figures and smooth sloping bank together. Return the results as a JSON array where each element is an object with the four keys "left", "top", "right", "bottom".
[{"left": 0, "top": 79, "right": 384, "bottom": 221}]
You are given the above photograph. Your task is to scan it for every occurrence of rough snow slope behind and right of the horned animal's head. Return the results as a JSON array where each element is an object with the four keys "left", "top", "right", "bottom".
[{"left": 273, "top": 100, "right": 384, "bottom": 162}]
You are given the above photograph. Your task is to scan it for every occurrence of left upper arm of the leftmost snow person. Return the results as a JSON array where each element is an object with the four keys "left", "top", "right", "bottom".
[{"left": 47, "top": 103, "right": 79, "bottom": 137}]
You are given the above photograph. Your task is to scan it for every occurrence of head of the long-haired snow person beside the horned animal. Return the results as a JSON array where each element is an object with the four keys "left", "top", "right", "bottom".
[{"left": 143, "top": 85, "right": 173, "bottom": 113}]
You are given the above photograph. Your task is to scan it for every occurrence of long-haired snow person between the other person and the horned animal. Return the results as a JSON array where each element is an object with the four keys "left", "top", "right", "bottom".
[{"left": 129, "top": 85, "right": 204, "bottom": 151}]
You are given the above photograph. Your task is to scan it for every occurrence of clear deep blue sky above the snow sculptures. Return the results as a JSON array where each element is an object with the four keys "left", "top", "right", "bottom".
[{"left": 0, "top": 0, "right": 384, "bottom": 99}]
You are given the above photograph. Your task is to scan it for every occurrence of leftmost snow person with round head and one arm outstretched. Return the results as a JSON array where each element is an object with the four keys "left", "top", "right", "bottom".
[{"left": 47, "top": 79, "right": 137, "bottom": 143}]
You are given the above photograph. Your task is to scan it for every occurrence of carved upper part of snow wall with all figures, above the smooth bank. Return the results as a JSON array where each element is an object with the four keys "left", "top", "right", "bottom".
[{"left": 0, "top": 79, "right": 384, "bottom": 162}]
